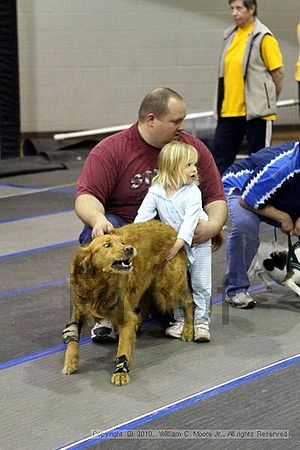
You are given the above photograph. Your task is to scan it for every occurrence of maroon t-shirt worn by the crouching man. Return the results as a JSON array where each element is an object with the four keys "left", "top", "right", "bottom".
[{"left": 76, "top": 124, "right": 225, "bottom": 222}]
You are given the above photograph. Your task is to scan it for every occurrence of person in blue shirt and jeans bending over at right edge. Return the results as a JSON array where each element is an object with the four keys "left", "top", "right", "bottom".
[{"left": 222, "top": 141, "right": 300, "bottom": 308}]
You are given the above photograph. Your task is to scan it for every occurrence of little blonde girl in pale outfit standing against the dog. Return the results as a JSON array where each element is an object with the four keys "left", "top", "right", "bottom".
[{"left": 134, "top": 141, "right": 211, "bottom": 342}]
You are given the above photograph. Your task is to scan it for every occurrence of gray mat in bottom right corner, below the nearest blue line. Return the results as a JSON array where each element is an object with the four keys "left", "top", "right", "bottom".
[{"left": 87, "top": 363, "right": 300, "bottom": 450}]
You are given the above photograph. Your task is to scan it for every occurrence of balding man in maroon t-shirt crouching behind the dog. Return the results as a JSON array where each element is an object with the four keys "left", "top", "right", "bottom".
[{"left": 75, "top": 87, "right": 227, "bottom": 342}]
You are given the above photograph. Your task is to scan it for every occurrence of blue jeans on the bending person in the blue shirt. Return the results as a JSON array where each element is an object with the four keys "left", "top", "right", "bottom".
[{"left": 224, "top": 195, "right": 280, "bottom": 297}]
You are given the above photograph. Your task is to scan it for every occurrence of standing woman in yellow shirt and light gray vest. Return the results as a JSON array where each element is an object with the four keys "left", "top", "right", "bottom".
[{"left": 212, "top": 0, "right": 284, "bottom": 174}]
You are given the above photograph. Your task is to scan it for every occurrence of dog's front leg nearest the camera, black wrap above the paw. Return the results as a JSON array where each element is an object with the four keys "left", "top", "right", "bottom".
[{"left": 111, "top": 312, "right": 138, "bottom": 386}]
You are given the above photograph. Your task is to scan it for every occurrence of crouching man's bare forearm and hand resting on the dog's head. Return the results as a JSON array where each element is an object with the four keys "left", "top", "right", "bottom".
[{"left": 75, "top": 194, "right": 113, "bottom": 238}]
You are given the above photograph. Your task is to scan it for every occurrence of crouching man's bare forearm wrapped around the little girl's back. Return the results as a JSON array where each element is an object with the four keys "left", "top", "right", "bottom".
[{"left": 193, "top": 200, "right": 227, "bottom": 245}]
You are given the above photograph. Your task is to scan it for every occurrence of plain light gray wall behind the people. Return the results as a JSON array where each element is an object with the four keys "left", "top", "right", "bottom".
[{"left": 17, "top": 0, "right": 300, "bottom": 132}]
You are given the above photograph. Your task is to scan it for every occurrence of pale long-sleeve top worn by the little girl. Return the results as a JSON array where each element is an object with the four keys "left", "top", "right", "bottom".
[{"left": 134, "top": 184, "right": 207, "bottom": 245}]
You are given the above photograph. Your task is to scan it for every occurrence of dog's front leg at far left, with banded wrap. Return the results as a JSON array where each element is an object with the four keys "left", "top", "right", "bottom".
[{"left": 62, "top": 319, "right": 82, "bottom": 375}]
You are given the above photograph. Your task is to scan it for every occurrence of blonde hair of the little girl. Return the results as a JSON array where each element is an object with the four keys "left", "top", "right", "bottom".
[{"left": 152, "top": 141, "right": 198, "bottom": 190}]
